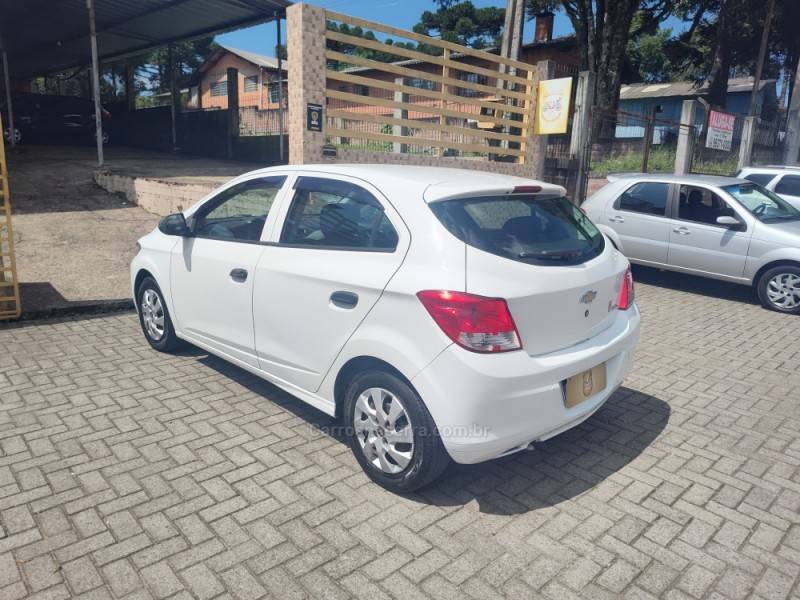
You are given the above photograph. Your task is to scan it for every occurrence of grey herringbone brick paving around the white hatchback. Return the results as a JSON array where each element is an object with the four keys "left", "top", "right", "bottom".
[{"left": 0, "top": 271, "right": 800, "bottom": 600}]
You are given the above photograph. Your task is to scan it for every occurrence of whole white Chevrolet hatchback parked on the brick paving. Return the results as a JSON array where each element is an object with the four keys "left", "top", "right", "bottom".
[{"left": 131, "top": 165, "right": 639, "bottom": 492}]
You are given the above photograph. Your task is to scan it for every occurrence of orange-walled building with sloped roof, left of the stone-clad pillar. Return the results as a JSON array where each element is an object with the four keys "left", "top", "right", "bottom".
[{"left": 190, "top": 46, "right": 288, "bottom": 110}]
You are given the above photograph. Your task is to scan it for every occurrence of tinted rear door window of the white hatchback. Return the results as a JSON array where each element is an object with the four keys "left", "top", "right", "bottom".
[{"left": 280, "top": 177, "right": 397, "bottom": 251}]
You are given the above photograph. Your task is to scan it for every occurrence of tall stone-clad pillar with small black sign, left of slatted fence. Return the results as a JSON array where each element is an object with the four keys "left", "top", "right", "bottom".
[{"left": 286, "top": 4, "right": 326, "bottom": 165}]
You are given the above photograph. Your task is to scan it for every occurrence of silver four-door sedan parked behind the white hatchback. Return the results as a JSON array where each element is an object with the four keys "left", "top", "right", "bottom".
[{"left": 582, "top": 174, "right": 800, "bottom": 314}]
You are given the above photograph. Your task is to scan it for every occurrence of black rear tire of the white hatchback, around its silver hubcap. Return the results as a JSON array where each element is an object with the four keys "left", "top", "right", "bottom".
[{"left": 343, "top": 370, "right": 450, "bottom": 494}]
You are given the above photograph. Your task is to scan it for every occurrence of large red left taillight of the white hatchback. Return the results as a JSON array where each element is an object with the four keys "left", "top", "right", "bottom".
[{"left": 417, "top": 290, "right": 522, "bottom": 352}]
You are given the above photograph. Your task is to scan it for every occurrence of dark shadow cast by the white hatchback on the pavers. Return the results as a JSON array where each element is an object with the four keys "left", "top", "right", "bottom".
[{"left": 198, "top": 346, "right": 670, "bottom": 515}]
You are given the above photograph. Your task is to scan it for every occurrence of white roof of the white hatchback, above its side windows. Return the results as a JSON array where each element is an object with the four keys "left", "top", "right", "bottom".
[{"left": 247, "top": 163, "right": 566, "bottom": 202}]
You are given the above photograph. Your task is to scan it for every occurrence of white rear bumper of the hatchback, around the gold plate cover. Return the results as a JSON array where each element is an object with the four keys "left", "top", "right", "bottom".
[{"left": 412, "top": 306, "right": 640, "bottom": 464}]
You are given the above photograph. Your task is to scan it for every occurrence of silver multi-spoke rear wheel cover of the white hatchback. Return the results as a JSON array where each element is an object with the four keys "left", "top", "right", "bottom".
[{"left": 353, "top": 387, "right": 414, "bottom": 474}]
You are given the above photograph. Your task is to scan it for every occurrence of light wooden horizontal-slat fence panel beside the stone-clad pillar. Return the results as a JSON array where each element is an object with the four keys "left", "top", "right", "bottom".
[{"left": 325, "top": 11, "right": 535, "bottom": 164}]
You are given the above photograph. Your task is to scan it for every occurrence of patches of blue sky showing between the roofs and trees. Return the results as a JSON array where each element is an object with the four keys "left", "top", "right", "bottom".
[{"left": 217, "top": 0, "right": 682, "bottom": 56}]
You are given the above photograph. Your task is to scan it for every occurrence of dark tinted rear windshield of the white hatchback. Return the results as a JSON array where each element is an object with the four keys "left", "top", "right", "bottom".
[{"left": 430, "top": 194, "right": 605, "bottom": 266}]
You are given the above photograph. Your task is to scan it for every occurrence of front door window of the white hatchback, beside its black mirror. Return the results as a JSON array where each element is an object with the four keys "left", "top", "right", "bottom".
[{"left": 193, "top": 176, "right": 286, "bottom": 242}]
